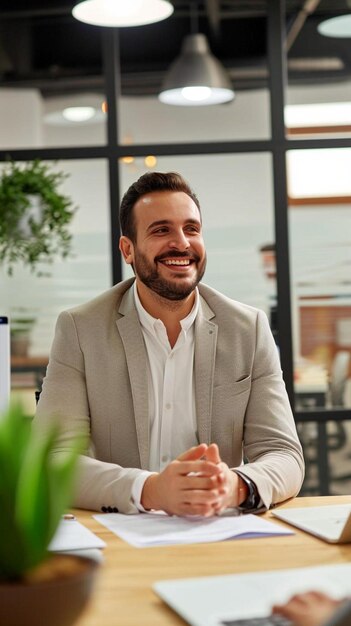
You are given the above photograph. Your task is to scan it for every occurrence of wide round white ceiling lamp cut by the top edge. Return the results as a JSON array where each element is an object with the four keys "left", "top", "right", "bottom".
[{"left": 72, "top": 0, "right": 173, "bottom": 27}]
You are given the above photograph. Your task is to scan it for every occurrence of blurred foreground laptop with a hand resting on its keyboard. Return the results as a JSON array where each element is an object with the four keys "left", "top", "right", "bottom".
[{"left": 153, "top": 563, "right": 351, "bottom": 626}]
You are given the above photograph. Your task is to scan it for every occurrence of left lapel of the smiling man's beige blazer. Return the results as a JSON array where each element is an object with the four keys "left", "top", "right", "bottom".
[{"left": 117, "top": 289, "right": 149, "bottom": 469}]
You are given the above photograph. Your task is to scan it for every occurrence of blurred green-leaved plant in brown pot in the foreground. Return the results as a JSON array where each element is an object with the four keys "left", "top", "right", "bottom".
[{"left": 0, "top": 403, "right": 97, "bottom": 626}]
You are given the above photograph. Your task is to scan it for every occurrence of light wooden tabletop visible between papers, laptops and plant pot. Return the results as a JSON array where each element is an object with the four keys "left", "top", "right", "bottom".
[{"left": 75, "top": 496, "right": 351, "bottom": 626}]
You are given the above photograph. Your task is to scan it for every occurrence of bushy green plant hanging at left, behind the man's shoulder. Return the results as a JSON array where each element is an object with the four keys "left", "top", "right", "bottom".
[{"left": 0, "top": 160, "right": 76, "bottom": 275}]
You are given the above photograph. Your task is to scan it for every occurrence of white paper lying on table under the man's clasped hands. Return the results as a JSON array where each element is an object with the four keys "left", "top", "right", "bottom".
[{"left": 94, "top": 512, "right": 293, "bottom": 548}]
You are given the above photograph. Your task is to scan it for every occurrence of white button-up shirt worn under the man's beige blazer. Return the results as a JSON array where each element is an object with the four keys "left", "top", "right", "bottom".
[{"left": 132, "top": 283, "right": 199, "bottom": 511}]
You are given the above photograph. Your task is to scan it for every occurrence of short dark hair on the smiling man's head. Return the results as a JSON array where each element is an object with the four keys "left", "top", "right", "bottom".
[{"left": 119, "top": 172, "right": 201, "bottom": 241}]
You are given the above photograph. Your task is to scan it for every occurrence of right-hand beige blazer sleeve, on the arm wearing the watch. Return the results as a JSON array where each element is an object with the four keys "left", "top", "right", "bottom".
[{"left": 233, "top": 311, "right": 304, "bottom": 508}]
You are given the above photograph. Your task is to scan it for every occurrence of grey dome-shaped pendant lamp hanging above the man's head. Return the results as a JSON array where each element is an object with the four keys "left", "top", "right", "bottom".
[{"left": 158, "top": 33, "right": 234, "bottom": 106}]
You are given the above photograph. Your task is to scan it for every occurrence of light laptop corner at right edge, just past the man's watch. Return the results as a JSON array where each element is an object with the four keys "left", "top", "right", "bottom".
[{"left": 271, "top": 504, "right": 351, "bottom": 543}]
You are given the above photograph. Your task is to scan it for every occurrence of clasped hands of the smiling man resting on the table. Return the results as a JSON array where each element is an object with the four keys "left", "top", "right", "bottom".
[{"left": 141, "top": 443, "right": 247, "bottom": 517}]
